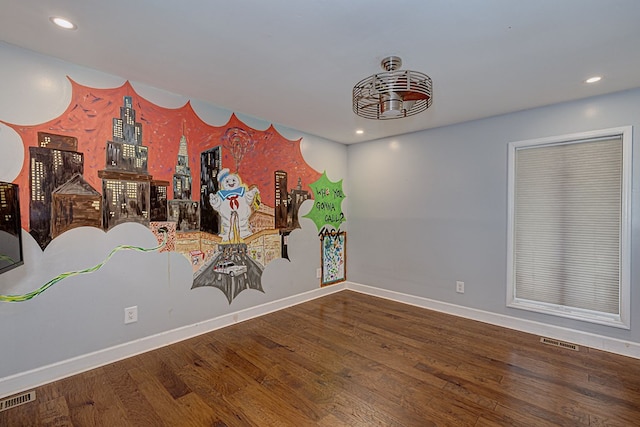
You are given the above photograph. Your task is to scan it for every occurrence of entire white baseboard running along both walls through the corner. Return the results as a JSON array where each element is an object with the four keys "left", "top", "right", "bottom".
[{"left": 0, "top": 282, "right": 640, "bottom": 398}]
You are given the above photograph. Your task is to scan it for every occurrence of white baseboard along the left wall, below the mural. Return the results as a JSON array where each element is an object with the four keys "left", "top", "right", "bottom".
[{"left": 0, "top": 283, "right": 345, "bottom": 399}]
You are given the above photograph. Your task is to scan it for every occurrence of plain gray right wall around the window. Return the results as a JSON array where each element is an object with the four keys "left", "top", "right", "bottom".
[{"left": 348, "top": 89, "right": 640, "bottom": 342}]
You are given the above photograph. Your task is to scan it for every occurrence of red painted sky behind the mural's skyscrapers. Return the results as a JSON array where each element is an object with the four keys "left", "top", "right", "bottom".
[{"left": 2, "top": 79, "right": 321, "bottom": 230}]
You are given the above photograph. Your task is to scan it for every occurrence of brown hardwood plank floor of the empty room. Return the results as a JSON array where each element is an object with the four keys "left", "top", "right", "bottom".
[{"left": 0, "top": 291, "right": 640, "bottom": 427}]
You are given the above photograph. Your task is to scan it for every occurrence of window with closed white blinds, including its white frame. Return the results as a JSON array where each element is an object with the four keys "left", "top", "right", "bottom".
[{"left": 507, "top": 127, "right": 631, "bottom": 328}]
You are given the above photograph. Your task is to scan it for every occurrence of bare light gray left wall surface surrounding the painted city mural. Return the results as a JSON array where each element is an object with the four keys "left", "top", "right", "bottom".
[{"left": 0, "top": 43, "right": 346, "bottom": 379}]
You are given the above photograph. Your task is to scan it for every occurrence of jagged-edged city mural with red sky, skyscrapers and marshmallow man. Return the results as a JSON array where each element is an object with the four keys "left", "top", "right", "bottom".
[{"left": 2, "top": 79, "right": 321, "bottom": 303}]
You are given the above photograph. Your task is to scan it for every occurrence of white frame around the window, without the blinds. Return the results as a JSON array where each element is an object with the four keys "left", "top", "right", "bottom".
[{"left": 506, "top": 126, "right": 633, "bottom": 329}]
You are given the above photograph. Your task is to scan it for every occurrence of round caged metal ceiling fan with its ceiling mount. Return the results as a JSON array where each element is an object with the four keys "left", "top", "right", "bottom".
[{"left": 353, "top": 56, "right": 433, "bottom": 120}]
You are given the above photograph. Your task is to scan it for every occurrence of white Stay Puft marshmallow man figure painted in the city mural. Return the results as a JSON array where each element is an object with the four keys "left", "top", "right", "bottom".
[{"left": 209, "top": 168, "right": 260, "bottom": 243}]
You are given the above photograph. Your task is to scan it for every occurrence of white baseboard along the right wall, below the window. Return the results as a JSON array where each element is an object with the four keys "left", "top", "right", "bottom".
[{"left": 346, "top": 282, "right": 640, "bottom": 359}]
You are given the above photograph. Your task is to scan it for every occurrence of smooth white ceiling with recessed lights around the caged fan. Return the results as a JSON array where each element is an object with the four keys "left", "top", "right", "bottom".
[{"left": 0, "top": 0, "right": 640, "bottom": 144}]
